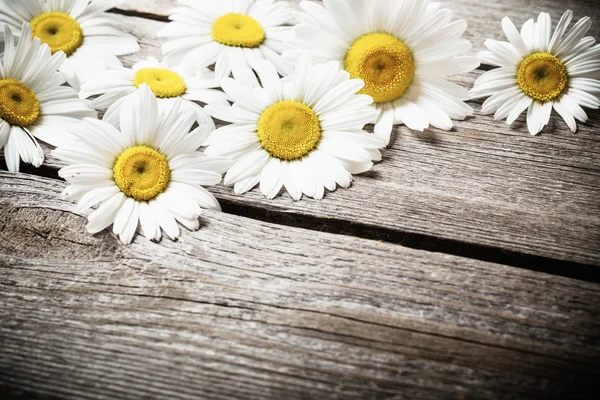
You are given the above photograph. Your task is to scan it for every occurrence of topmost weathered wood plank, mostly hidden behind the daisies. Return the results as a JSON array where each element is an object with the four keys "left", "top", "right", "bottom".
[{"left": 111, "top": 0, "right": 600, "bottom": 56}]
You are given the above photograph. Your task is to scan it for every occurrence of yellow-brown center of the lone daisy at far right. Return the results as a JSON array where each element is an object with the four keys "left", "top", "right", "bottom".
[{"left": 517, "top": 53, "right": 569, "bottom": 103}]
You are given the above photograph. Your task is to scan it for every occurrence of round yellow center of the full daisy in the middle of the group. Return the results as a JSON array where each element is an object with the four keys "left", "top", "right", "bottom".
[{"left": 258, "top": 101, "right": 321, "bottom": 161}]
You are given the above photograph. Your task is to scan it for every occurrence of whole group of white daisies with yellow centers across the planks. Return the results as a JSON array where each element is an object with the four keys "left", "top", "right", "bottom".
[{"left": 0, "top": 0, "right": 600, "bottom": 244}]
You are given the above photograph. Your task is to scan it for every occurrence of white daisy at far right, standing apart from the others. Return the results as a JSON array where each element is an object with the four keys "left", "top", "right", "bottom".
[{"left": 471, "top": 11, "right": 600, "bottom": 135}]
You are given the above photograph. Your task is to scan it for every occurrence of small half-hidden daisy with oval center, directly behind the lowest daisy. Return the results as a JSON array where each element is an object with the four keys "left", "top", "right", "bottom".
[{"left": 79, "top": 58, "right": 229, "bottom": 130}]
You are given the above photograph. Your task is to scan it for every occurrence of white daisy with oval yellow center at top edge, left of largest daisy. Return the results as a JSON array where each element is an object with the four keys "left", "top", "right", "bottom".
[{"left": 158, "top": 0, "right": 293, "bottom": 82}]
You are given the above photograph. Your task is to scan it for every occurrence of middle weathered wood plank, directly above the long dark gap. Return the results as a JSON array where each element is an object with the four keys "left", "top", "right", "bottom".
[{"left": 3, "top": 12, "right": 600, "bottom": 265}]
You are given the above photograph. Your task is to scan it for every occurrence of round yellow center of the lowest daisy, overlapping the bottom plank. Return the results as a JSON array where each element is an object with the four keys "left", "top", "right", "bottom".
[{"left": 113, "top": 146, "right": 171, "bottom": 201}]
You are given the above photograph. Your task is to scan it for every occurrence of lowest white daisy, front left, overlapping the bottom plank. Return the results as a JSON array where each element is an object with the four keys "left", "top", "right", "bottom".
[{"left": 54, "top": 85, "right": 229, "bottom": 244}]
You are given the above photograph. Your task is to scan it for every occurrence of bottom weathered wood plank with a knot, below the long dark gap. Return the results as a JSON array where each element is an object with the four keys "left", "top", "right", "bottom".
[{"left": 0, "top": 172, "right": 600, "bottom": 399}]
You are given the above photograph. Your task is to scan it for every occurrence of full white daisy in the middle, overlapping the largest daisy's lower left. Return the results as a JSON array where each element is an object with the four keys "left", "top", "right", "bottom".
[{"left": 206, "top": 57, "right": 384, "bottom": 200}]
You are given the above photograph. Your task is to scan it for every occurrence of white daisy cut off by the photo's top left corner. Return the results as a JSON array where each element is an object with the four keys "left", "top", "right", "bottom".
[{"left": 0, "top": 0, "right": 139, "bottom": 87}]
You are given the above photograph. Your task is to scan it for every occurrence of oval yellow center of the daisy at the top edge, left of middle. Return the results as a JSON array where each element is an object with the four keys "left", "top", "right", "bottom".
[{"left": 211, "top": 13, "right": 266, "bottom": 48}]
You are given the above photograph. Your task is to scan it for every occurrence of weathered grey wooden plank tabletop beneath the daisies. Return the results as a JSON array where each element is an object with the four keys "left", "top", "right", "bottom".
[{"left": 0, "top": 0, "right": 600, "bottom": 399}]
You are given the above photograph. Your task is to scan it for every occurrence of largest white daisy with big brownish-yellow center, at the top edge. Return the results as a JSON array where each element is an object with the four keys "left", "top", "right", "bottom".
[{"left": 284, "top": 0, "right": 479, "bottom": 143}]
